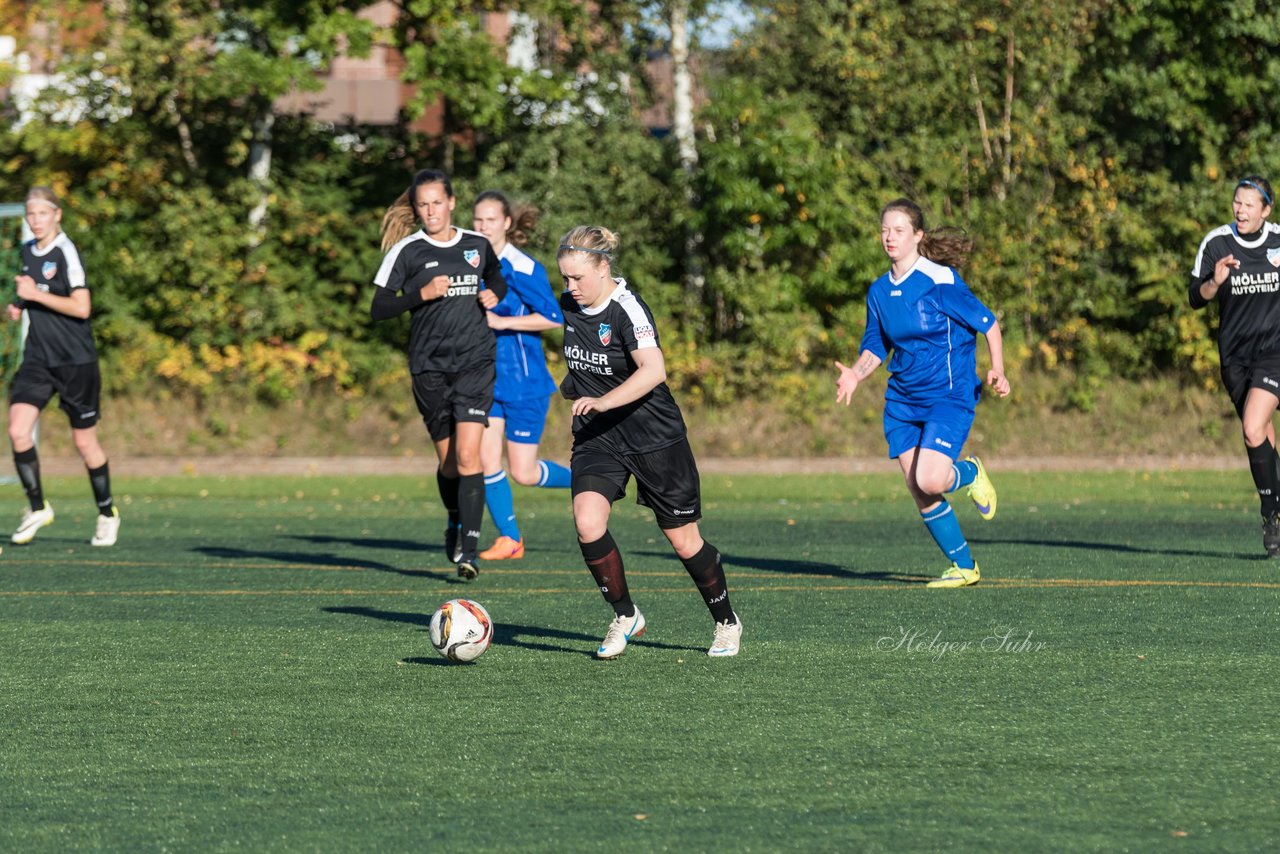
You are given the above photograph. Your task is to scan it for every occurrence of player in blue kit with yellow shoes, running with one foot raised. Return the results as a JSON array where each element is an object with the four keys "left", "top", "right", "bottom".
[{"left": 836, "top": 198, "right": 1009, "bottom": 588}]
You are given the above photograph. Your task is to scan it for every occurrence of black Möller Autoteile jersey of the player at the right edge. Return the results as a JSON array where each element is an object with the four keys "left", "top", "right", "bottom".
[{"left": 1189, "top": 223, "right": 1280, "bottom": 365}]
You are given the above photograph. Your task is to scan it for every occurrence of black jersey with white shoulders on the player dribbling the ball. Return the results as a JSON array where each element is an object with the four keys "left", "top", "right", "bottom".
[{"left": 561, "top": 279, "right": 685, "bottom": 455}]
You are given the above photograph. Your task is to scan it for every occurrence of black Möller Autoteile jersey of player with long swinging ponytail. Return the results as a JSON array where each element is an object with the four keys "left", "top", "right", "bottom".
[{"left": 374, "top": 227, "right": 507, "bottom": 374}]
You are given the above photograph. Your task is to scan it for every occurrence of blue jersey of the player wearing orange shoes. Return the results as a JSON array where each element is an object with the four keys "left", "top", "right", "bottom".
[{"left": 493, "top": 243, "right": 564, "bottom": 401}]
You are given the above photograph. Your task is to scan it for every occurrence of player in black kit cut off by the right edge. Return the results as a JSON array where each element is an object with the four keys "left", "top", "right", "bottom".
[{"left": 1189, "top": 175, "right": 1280, "bottom": 557}]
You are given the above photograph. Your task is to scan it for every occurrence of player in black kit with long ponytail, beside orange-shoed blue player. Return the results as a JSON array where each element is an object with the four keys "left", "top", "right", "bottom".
[{"left": 372, "top": 169, "right": 507, "bottom": 580}]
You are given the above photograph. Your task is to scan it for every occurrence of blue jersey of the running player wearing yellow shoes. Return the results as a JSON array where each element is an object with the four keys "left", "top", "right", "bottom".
[{"left": 861, "top": 256, "right": 996, "bottom": 407}]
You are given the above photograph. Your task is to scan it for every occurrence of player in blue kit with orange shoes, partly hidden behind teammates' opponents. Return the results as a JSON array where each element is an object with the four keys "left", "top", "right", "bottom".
[{"left": 472, "top": 189, "right": 570, "bottom": 561}]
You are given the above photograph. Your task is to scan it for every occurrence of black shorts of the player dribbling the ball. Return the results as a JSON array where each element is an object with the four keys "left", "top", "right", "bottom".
[{"left": 570, "top": 439, "right": 703, "bottom": 530}]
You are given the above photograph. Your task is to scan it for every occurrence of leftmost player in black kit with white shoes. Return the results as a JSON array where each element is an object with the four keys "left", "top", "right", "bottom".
[{"left": 8, "top": 187, "right": 120, "bottom": 545}]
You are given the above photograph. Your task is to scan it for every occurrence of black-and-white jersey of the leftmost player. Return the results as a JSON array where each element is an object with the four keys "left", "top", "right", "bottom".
[{"left": 22, "top": 233, "right": 97, "bottom": 367}]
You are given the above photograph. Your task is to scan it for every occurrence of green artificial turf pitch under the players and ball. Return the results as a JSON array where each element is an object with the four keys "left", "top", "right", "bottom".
[{"left": 0, "top": 463, "right": 1280, "bottom": 851}]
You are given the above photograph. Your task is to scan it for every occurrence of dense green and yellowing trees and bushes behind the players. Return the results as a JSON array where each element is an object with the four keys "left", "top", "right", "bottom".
[{"left": 0, "top": 0, "right": 1280, "bottom": 427}]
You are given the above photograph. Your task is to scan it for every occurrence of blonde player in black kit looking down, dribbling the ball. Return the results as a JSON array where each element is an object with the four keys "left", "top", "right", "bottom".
[{"left": 556, "top": 225, "right": 742, "bottom": 658}]
